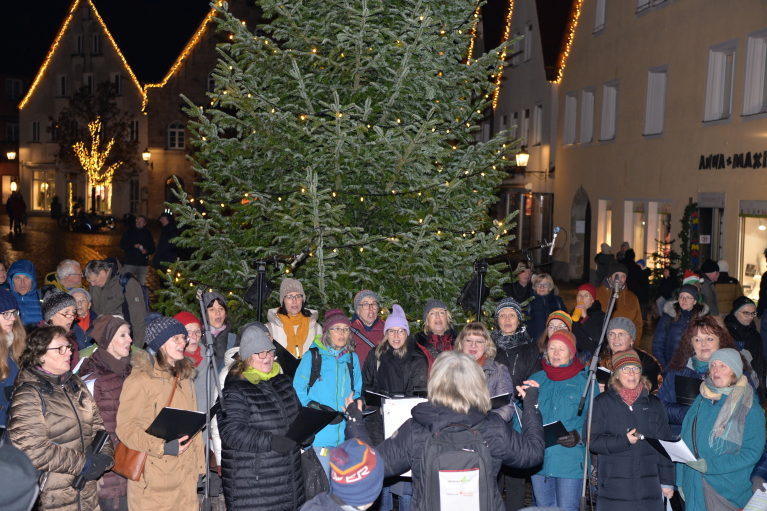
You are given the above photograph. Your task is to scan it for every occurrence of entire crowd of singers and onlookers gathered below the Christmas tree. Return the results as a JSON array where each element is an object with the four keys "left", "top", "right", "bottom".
[{"left": 0, "top": 237, "right": 767, "bottom": 511}]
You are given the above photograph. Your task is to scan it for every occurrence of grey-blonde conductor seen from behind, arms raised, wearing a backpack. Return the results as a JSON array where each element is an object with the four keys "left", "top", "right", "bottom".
[{"left": 346, "top": 351, "right": 545, "bottom": 511}]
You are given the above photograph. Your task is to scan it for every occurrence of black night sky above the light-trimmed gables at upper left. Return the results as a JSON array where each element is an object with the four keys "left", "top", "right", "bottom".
[{"left": 0, "top": 0, "right": 210, "bottom": 82}]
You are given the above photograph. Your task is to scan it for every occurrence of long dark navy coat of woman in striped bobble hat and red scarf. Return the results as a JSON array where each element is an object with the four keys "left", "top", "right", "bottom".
[{"left": 591, "top": 388, "right": 676, "bottom": 511}]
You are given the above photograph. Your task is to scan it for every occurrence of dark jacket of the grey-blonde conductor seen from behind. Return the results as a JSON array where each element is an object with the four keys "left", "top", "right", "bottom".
[{"left": 347, "top": 402, "right": 545, "bottom": 511}]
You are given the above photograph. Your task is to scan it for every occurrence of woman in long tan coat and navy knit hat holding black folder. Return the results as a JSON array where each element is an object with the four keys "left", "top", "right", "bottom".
[{"left": 116, "top": 312, "right": 205, "bottom": 511}]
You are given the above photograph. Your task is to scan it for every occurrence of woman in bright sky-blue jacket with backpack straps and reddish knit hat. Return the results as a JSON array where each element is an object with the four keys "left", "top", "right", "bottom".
[{"left": 293, "top": 309, "right": 362, "bottom": 480}]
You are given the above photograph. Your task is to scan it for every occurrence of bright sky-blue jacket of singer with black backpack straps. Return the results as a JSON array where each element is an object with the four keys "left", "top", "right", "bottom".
[{"left": 293, "top": 335, "right": 362, "bottom": 447}]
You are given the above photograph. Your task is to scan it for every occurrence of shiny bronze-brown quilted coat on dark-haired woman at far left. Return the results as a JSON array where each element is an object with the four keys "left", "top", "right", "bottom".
[{"left": 8, "top": 369, "right": 114, "bottom": 511}]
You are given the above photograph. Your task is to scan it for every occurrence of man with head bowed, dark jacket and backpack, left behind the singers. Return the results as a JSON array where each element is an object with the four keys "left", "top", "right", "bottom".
[{"left": 83, "top": 257, "right": 149, "bottom": 348}]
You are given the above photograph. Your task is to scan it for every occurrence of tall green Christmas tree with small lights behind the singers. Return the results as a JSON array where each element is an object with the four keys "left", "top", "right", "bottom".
[{"left": 163, "top": 0, "right": 511, "bottom": 328}]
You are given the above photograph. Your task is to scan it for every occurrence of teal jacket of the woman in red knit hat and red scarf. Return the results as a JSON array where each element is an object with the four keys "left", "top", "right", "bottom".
[{"left": 530, "top": 369, "right": 599, "bottom": 479}]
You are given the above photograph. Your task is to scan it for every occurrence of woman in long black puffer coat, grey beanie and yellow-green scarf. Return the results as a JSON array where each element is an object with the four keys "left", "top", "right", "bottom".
[{"left": 216, "top": 325, "right": 306, "bottom": 511}]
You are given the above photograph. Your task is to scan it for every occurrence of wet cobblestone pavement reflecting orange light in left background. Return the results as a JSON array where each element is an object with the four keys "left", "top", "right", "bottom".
[{"left": 0, "top": 215, "right": 160, "bottom": 290}]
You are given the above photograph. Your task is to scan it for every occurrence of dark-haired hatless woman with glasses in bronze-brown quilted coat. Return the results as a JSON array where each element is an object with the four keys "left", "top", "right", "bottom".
[{"left": 8, "top": 326, "right": 114, "bottom": 511}]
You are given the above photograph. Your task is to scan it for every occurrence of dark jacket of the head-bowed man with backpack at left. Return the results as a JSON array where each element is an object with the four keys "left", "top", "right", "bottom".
[{"left": 91, "top": 259, "right": 146, "bottom": 348}]
